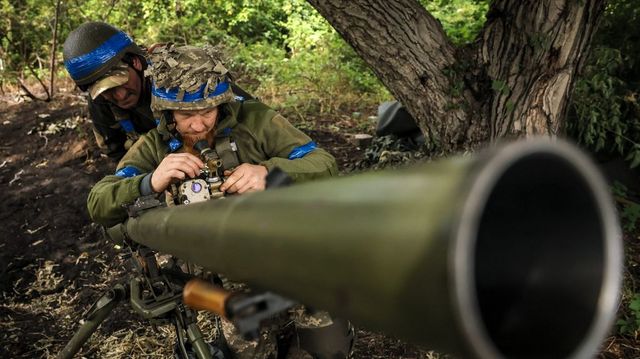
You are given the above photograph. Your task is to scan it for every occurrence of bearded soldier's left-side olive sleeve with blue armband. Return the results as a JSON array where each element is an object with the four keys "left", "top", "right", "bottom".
[{"left": 87, "top": 134, "right": 161, "bottom": 226}]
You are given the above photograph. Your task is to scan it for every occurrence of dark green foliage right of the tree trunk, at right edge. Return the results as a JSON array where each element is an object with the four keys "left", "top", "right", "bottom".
[{"left": 567, "top": 0, "right": 640, "bottom": 168}]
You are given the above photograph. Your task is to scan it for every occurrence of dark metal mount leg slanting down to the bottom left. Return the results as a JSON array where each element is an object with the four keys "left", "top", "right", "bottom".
[{"left": 57, "top": 284, "right": 127, "bottom": 359}]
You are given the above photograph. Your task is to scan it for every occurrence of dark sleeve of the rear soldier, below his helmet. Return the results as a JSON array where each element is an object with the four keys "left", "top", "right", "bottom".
[{"left": 88, "top": 96, "right": 127, "bottom": 160}]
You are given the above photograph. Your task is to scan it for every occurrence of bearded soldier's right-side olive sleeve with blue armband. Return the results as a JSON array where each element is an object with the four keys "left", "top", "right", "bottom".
[{"left": 258, "top": 114, "right": 338, "bottom": 182}]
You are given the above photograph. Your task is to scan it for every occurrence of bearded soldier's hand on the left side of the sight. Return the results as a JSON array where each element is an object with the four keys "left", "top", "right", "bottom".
[{"left": 151, "top": 153, "right": 204, "bottom": 193}]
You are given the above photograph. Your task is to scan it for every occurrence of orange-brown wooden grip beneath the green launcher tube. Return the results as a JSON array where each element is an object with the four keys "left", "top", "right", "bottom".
[{"left": 182, "top": 279, "right": 231, "bottom": 318}]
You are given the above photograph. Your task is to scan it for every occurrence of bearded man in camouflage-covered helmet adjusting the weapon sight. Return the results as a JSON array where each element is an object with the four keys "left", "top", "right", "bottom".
[{"left": 88, "top": 46, "right": 354, "bottom": 358}]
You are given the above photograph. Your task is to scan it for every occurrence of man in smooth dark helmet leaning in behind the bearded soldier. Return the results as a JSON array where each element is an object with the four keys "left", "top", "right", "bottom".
[{"left": 63, "top": 22, "right": 156, "bottom": 159}]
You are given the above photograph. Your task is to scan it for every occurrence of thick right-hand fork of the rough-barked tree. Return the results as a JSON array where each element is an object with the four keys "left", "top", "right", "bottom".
[{"left": 477, "top": 0, "right": 605, "bottom": 139}]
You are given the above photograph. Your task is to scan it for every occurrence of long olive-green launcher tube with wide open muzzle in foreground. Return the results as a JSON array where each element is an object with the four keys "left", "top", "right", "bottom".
[{"left": 112, "top": 140, "right": 622, "bottom": 359}]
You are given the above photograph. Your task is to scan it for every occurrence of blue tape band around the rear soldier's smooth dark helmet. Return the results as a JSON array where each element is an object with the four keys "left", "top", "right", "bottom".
[{"left": 64, "top": 31, "right": 133, "bottom": 81}]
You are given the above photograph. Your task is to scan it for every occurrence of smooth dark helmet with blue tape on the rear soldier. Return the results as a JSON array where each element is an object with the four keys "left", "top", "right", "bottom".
[{"left": 62, "top": 21, "right": 145, "bottom": 90}]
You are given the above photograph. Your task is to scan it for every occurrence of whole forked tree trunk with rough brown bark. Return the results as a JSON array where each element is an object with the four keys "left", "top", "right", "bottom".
[{"left": 308, "top": 0, "right": 605, "bottom": 152}]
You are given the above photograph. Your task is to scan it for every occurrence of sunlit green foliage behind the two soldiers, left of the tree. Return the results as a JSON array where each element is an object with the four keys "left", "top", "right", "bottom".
[{"left": 0, "top": 0, "right": 389, "bottom": 113}]
